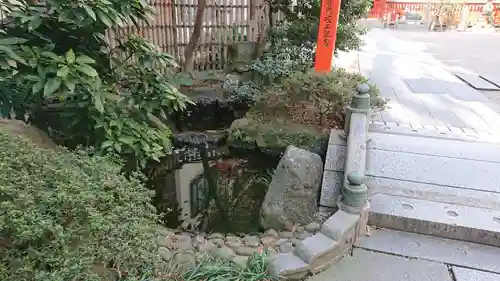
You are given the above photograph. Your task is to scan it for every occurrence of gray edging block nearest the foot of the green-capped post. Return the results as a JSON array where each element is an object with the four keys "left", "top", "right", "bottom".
[{"left": 321, "top": 210, "right": 359, "bottom": 240}]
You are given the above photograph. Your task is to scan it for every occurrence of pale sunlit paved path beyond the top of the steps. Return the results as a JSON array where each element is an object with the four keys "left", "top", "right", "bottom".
[{"left": 359, "top": 29, "right": 500, "bottom": 141}]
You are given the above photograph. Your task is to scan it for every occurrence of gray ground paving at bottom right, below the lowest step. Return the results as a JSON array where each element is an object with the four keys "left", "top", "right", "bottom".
[{"left": 308, "top": 230, "right": 500, "bottom": 281}]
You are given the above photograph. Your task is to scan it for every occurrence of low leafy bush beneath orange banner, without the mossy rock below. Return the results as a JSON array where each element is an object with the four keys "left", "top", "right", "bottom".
[{"left": 253, "top": 68, "right": 385, "bottom": 128}]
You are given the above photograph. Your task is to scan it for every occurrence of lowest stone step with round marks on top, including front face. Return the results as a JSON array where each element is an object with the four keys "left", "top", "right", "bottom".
[{"left": 369, "top": 194, "right": 500, "bottom": 246}]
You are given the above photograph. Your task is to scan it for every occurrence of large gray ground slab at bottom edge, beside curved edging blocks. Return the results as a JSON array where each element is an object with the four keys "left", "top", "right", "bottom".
[{"left": 307, "top": 249, "right": 452, "bottom": 281}]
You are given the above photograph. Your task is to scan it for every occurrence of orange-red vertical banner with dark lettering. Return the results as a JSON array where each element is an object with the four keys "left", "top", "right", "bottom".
[{"left": 314, "top": 0, "right": 340, "bottom": 72}]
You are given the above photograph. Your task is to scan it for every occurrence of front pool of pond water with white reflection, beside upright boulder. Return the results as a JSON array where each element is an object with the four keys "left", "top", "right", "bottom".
[{"left": 150, "top": 145, "right": 280, "bottom": 233}]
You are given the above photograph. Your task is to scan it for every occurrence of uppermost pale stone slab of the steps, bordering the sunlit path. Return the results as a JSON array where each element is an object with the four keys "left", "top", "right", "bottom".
[{"left": 368, "top": 133, "right": 500, "bottom": 163}]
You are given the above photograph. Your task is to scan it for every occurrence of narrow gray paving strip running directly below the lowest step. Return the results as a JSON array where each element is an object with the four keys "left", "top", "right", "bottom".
[{"left": 356, "top": 229, "right": 500, "bottom": 272}]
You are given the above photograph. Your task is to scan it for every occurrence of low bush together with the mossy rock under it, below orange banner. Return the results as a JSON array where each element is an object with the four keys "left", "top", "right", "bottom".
[{"left": 228, "top": 69, "right": 386, "bottom": 155}]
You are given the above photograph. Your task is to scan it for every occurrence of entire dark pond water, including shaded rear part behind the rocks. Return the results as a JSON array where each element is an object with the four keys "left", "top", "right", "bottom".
[{"left": 148, "top": 87, "right": 281, "bottom": 233}]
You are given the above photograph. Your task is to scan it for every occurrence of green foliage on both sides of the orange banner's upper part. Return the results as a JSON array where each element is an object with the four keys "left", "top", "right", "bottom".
[{"left": 273, "top": 0, "right": 372, "bottom": 52}]
